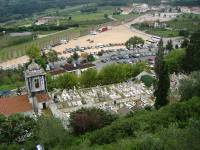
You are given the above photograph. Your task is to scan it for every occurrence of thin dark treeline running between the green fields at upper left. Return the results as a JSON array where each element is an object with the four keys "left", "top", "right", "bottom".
[{"left": 0, "top": 24, "right": 79, "bottom": 32}]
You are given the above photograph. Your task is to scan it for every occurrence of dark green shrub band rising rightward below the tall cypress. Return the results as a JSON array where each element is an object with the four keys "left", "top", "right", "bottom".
[{"left": 89, "top": 97, "right": 200, "bottom": 144}]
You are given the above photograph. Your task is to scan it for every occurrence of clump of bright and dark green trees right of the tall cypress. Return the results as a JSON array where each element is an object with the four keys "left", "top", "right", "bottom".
[{"left": 165, "top": 31, "right": 200, "bottom": 74}]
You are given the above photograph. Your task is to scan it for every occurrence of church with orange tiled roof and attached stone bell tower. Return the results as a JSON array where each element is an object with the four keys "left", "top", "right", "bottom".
[{"left": 0, "top": 61, "right": 50, "bottom": 116}]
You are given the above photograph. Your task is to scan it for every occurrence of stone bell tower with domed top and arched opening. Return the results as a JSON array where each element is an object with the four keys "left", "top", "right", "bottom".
[{"left": 25, "top": 60, "right": 47, "bottom": 113}]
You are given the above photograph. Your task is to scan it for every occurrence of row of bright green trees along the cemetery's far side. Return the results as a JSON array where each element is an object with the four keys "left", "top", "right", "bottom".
[{"left": 47, "top": 62, "right": 146, "bottom": 91}]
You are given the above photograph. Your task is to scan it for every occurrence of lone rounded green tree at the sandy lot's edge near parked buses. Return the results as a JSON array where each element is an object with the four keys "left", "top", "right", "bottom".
[{"left": 125, "top": 36, "right": 144, "bottom": 49}]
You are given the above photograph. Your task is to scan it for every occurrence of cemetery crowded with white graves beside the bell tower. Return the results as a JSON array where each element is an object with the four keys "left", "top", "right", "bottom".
[{"left": 50, "top": 81, "right": 154, "bottom": 121}]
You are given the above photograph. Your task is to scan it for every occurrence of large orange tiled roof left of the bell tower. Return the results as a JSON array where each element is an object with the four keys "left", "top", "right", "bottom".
[{"left": 0, "top": 95, "right": 32, "bottom": 116}]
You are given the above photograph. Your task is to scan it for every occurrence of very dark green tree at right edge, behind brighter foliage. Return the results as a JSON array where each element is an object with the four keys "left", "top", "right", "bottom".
[{"left": 183, "top": 31, "right": 200, "bottom": 72}]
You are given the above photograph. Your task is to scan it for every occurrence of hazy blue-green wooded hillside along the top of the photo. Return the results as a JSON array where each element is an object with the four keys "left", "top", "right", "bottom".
[{"left": 0, "top": 0, "right": 200, "bottom": 22}]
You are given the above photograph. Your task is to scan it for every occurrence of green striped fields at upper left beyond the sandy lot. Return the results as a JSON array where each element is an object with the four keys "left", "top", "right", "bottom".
[{"left": 0, "top": 4, "right": 117, "bottom": 62}]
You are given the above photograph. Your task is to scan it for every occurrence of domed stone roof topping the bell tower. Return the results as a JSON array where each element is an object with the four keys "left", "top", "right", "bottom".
[{"left": 25, "top": 60, "right": 45, "bottom": 77}]
